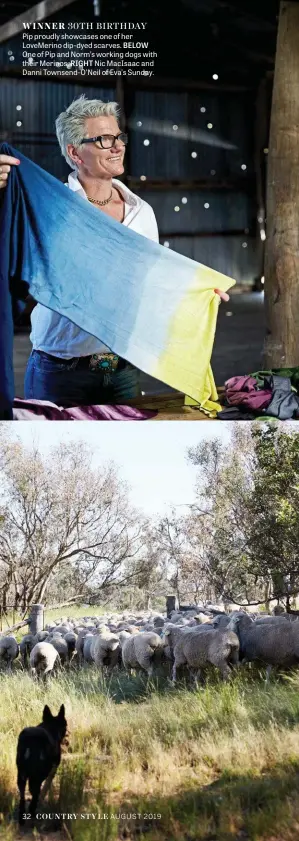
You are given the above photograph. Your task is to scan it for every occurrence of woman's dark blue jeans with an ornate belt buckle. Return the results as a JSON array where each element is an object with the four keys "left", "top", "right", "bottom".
[{"left": 24, "top": 350, "right": 141, "bottom": 408}]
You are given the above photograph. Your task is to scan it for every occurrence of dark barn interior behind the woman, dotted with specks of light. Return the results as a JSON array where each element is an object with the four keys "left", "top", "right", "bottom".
[{"left": 0, "top": 0, "right": 288, "bottom": 406}]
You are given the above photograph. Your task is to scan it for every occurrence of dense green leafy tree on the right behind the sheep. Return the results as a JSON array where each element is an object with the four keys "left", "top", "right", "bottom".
[{"left": 184, "top": 422, "right": 299, "bottom": 606}]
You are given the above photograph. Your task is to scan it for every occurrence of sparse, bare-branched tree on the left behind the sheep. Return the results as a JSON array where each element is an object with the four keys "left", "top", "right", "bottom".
[{"left": 0, "top": 436, "right": 150, "bottom": 613}]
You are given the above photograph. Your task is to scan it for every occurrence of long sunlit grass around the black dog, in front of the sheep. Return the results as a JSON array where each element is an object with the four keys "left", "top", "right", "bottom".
[{"left": 0, "top": 668, "right": 299, "bottom": 841}]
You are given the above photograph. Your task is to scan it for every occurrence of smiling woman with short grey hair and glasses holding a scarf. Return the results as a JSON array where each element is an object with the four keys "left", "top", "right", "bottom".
[{"left": 0, "top": 95, "right": 228, "bottom": 407}]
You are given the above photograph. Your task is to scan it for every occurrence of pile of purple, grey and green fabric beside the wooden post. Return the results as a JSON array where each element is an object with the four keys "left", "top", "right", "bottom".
[{"left": 217, "top": 368, "right": 299, "bottom": 420}]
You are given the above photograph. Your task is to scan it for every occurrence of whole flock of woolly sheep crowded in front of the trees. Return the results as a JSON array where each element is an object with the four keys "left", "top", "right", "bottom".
[{"left": 0, "top": 607, "right": 299, "bottom": 684}]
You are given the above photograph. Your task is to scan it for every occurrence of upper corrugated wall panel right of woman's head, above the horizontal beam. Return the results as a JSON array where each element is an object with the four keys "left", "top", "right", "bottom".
[{"left": 130, "top": 91, "right": 254, "bottom": 181}]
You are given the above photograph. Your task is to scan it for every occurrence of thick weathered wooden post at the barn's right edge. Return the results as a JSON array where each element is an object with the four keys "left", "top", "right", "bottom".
[{"left": 264, "top": 0, "right": 299, "bottom": 368}]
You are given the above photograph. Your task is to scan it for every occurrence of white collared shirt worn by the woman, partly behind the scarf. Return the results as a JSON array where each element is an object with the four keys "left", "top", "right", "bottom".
[{"left": 30, "top": 172, "right": 159, "bottom": 359}]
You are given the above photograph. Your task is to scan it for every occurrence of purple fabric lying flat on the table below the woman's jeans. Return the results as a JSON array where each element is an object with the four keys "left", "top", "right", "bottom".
[{"left": 13, "top": 397, "right": 157, "bottom": 421}]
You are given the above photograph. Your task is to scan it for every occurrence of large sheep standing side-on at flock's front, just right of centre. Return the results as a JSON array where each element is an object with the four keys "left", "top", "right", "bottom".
[{"left": 164, "top": 626, "right": 240, "bottom": 683}]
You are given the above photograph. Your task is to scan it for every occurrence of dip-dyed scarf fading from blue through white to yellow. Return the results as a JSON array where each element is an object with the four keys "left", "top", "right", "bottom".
[{"left": 0, "top": 143, "right": 234, "bottom": 416}]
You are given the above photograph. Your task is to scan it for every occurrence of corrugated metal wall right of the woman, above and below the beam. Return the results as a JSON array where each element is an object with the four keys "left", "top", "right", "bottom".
[{"left": 129, "top": 90, "right": 260, "bottom": 283}]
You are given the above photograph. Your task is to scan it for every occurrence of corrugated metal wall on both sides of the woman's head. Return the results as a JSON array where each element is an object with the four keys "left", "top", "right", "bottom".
[{"left": 0, "top": 76, "right": 259, "bottom": 283}]
